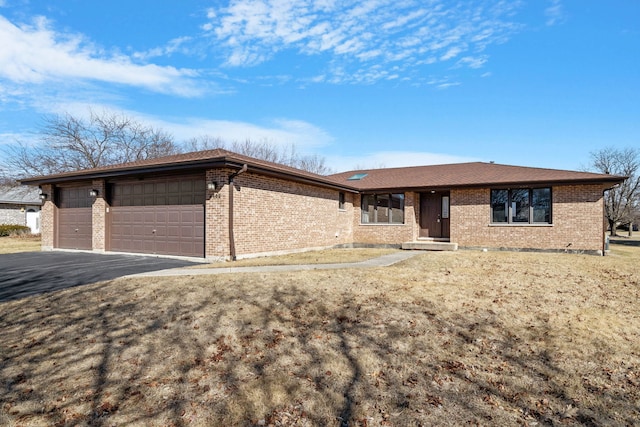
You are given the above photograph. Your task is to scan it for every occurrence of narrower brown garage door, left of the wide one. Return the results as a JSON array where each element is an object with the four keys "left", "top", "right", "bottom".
[{"left": 56, "top": 187, "right": 93, "bottom": 250}]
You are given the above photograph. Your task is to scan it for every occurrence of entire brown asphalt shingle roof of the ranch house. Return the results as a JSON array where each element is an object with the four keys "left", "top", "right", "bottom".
[{"left": 22, "top": 149, "right": 625, "bottom": 191}]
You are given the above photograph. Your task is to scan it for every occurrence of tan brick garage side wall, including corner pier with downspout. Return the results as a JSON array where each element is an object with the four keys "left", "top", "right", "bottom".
[{"left": 212, "top": 171, "right": 353, "bottom": 258}]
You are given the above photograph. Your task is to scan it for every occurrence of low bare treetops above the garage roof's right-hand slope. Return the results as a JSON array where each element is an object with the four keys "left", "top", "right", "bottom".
[{"left": 185, "top": 139, "right": 332, "bottom": 175}]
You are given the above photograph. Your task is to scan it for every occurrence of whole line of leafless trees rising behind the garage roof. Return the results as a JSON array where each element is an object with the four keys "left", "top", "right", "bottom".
[{"left": 0, "top": 111, "right": 332, "bottom": 178}]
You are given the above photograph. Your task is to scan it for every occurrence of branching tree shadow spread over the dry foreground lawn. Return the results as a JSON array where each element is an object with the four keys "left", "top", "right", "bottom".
[{"left": 0, "top": 275, "right": 637, "bottom": 426}]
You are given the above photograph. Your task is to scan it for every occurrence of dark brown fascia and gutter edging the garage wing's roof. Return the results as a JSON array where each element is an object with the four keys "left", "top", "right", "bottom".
[{"left": 20, "top": 157, "right": 358, "bottom": 193}]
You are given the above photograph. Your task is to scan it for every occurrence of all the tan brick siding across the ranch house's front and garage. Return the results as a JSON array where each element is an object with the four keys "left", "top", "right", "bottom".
[{"left": 33, "top": 173, "right": 604, "bottom": 259}]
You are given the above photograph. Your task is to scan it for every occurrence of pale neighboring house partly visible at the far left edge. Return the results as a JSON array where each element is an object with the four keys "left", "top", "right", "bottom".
[{"left": 0, "top": 185, "right": 42, "bottom": 234}]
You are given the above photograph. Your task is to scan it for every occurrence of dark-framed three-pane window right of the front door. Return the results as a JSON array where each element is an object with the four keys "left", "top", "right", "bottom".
[{"left": 491, "top": 188, "right": 551, "bottom": 224}]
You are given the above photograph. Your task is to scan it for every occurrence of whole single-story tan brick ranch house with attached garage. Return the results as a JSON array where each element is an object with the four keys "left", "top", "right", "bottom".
[{"left": 22, "top": 149, "right": 625, "bottom": 260}]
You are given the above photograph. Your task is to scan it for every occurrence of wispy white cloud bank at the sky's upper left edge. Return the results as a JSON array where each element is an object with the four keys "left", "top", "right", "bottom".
[{"left": 0, "top": 16, "right": 202, "bottom": 97}]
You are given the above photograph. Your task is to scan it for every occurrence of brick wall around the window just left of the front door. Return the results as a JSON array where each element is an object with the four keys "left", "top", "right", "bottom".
[{"left": 353, "top": 192, "right": 420, "bottom": 245}]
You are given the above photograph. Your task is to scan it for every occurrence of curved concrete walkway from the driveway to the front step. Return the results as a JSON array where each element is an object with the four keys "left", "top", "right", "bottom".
[{"left": 126, "top": 251, "right": 423, "bottom": 277}]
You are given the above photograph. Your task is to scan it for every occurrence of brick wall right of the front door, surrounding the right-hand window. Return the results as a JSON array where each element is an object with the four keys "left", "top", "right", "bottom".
[{"left": 451, "top": 185, "right": 605, "bottom": 252}]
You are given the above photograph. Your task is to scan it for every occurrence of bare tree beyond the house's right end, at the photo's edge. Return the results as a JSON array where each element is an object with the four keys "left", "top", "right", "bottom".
[{"left": 591, "top": 147, "right": 640, "bottom": 236}]
